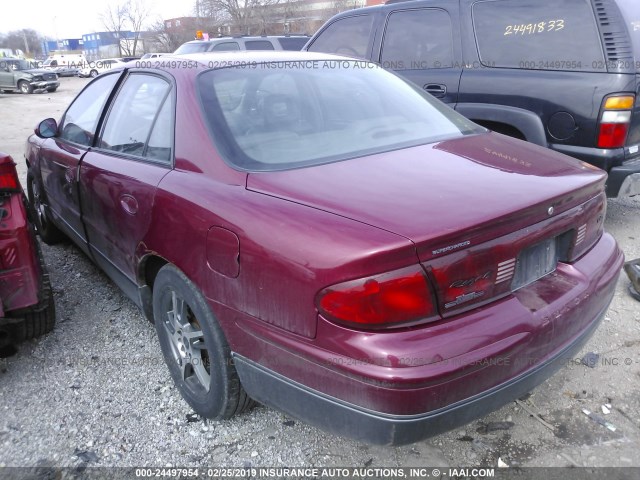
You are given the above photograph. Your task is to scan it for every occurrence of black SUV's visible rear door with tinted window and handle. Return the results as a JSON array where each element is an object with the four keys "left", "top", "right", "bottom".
[{"left": 378, "top": 2, "right": 462, "bottom": 107}]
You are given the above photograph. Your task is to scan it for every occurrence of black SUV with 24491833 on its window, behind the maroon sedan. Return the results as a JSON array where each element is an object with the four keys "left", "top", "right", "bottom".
[{"left": 305, "top": 0, "right": 640, "bottom": 197}]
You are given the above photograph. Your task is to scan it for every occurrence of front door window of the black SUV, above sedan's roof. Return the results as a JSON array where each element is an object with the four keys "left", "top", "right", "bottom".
[{"left": 309, "top": 15, "right": 373, "bottom": 58}]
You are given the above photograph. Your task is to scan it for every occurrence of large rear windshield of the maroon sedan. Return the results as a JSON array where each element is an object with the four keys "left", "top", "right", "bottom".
[{"left": 198, "top": 60, "right": 484, "bottom": 171}]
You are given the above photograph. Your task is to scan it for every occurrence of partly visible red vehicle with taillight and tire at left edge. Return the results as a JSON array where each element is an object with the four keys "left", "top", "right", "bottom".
[{"left": 0, "top": 152, "right": 55, "bottom": 356}]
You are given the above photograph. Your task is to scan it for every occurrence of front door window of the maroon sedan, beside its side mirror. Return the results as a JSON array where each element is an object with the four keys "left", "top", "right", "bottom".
[{"left": 59, "top": 74, "right": 119, "bottom": 146}]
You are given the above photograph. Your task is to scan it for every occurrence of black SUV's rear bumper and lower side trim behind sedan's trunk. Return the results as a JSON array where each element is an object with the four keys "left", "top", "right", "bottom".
[{"left": 549, "top": 144, "right": 640, "bottom": 198}]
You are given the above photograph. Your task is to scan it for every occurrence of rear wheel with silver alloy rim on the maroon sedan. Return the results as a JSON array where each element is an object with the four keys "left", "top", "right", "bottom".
[{"left": 153, "top": 264, "right": 253, "bottom": 420}]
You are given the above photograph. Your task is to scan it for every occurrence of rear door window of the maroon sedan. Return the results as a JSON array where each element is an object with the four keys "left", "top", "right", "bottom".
[{"left": 99, "top": 74, "right": 171, "bottom": 157}]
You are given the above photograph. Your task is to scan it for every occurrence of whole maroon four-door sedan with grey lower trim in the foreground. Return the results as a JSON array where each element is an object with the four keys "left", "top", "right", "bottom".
[{"left": 26, "top": 52, "right": 623, "bottom": 444}]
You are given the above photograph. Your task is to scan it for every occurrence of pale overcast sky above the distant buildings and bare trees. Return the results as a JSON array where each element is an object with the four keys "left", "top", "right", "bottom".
[{"left": 0, "top": 0, "right": 195, "bottom": 39}]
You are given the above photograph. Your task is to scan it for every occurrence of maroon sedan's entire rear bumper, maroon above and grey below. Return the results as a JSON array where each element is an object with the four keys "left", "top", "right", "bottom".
[{"left": 231, "top": 234, "right": 623, "bottom": 445}]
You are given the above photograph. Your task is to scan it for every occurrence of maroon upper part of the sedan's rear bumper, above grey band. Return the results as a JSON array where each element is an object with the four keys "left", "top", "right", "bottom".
[{"left": 224, "top": 234, "right": 623, "bottom": 415}]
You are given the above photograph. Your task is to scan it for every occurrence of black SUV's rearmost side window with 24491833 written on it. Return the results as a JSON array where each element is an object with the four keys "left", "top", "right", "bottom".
[{"left": 473, "top": 0, "right": 606, "bottom": 71}]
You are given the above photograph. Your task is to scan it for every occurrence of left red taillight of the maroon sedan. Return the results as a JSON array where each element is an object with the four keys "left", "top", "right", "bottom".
[{"left": 317, "top": 265, "right": 437, "bottom": 328}]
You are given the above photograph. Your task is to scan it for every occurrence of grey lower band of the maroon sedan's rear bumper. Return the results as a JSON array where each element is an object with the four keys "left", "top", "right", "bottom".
[{"left": 234, "top": 305, "right": 608, "bottom": 445}]
